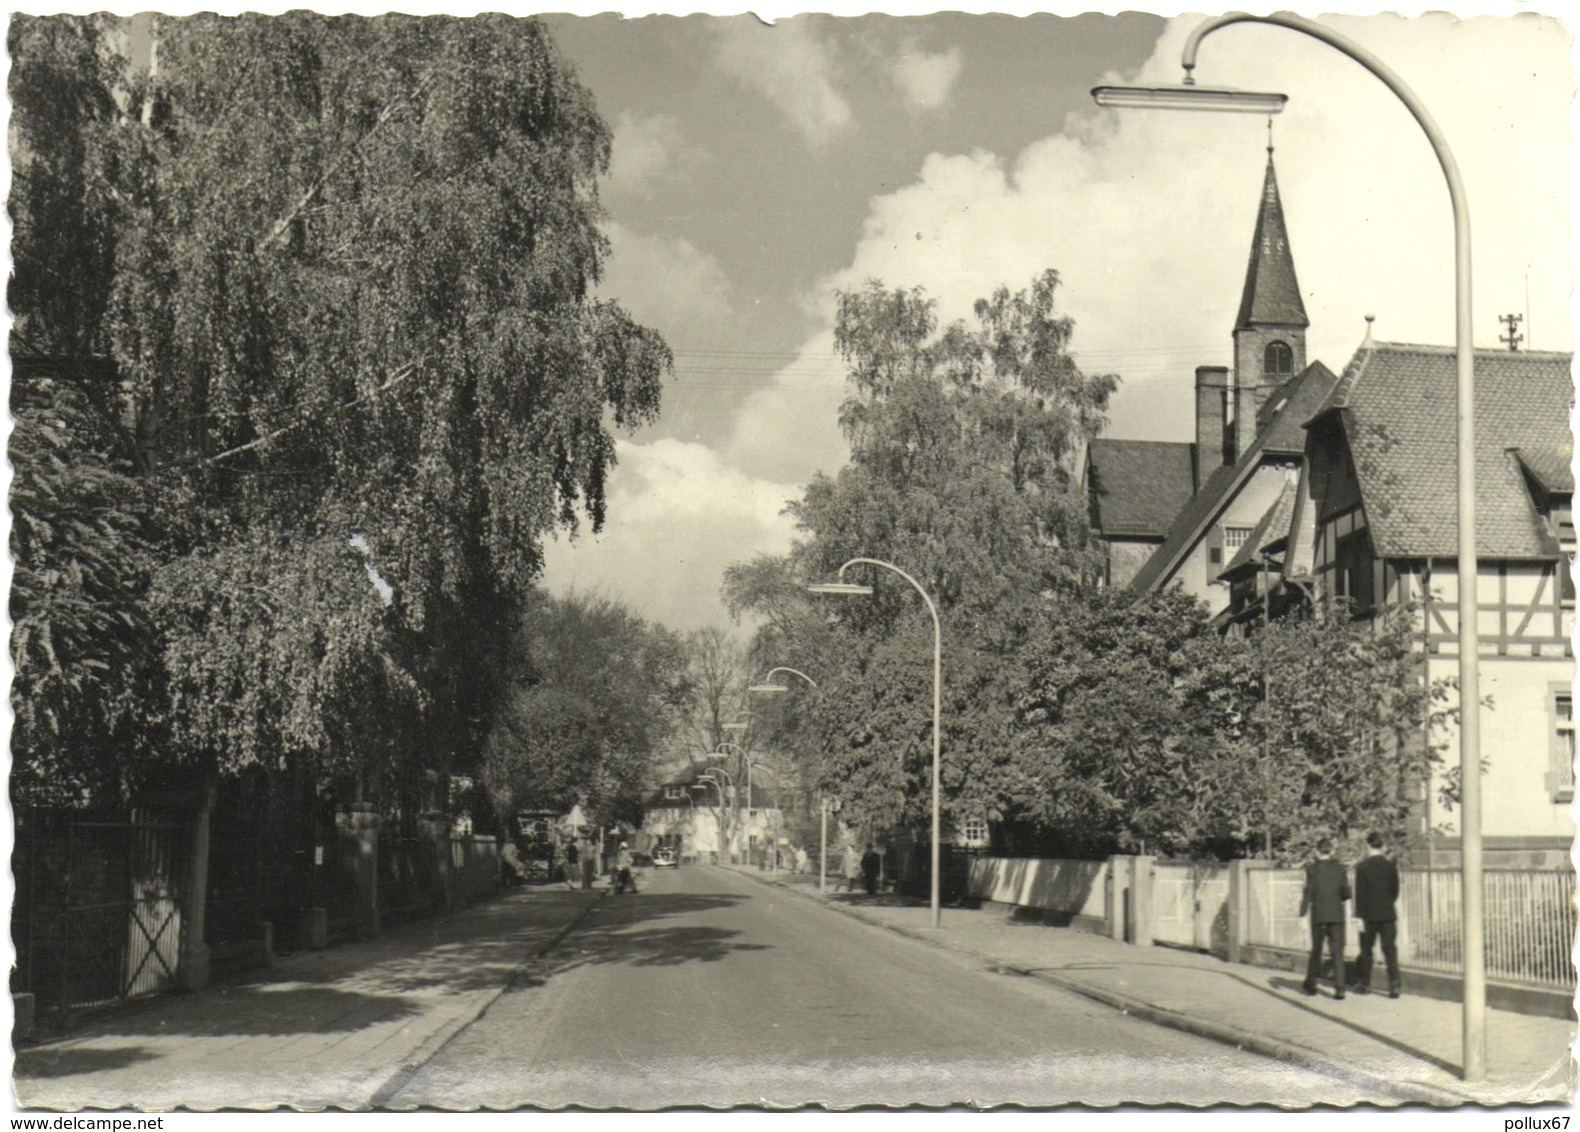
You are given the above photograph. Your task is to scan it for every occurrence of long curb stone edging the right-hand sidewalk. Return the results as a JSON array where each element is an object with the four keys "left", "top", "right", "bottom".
[{"left": 732, "top": 870, "right": 1477, "bottom": 1107}]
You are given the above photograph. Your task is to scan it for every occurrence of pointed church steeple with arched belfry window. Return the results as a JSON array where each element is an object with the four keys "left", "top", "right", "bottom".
[{"left": 1232, "top": 147, "right": 1311, "bottom": 458}]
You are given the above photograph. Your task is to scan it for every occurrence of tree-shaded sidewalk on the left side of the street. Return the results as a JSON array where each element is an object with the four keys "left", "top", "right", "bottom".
[{"left": 13, "top": 885, "right": 605, "bottom": 1111}]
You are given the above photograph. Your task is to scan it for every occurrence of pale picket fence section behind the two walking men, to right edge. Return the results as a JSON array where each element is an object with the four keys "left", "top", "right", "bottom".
[{"left": 1245, "top": 868, "right": 1575, "bottom": 988}]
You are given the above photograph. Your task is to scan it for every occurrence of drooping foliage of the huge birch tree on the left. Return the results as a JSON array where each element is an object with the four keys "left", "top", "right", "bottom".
[{"left": 9, "top": 13, "right": 670, "bottom": 815}]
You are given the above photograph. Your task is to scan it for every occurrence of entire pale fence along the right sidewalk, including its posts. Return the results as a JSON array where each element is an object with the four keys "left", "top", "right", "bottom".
[{"left": 969, "top": 857, "right": 1575, "bottom": 1017}]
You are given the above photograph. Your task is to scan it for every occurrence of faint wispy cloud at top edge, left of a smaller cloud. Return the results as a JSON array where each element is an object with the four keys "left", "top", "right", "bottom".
[{"left": 717, "top": 17, "right": 852, "bottom": 147}]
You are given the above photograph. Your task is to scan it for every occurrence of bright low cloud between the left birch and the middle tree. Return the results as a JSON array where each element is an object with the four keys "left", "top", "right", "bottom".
[{"left": 544, "top": 440, "right": 798, "bottom": 629}]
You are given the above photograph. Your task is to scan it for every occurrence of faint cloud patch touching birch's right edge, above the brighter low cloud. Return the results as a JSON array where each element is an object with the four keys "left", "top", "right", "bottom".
[{"left": 599, "top": 221, "right": 732, "bottom": 345}]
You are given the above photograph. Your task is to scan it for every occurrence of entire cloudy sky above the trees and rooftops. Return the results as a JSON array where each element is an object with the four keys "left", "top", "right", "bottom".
[{"left": 521, "top": 4, "right": 1574, "bottom": 628}]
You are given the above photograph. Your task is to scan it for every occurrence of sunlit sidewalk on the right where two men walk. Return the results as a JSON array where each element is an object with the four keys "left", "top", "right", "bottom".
[{"left": 736, "top": 868, "right": 1575, "bottom": 1105}]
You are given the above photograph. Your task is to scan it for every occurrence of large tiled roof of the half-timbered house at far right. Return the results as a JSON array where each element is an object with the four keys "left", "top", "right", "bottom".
[{"left": 1316, "top": 343, "right": 1574, "bottom": 558}]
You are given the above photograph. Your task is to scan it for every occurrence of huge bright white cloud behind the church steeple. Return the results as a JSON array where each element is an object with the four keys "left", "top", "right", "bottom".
[{"left": 822, "top": 16, "right": 1574, "bottom": 440}]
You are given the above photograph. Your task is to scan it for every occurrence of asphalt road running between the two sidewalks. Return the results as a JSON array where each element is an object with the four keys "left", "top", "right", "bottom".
[{"left": 382, "top": 865, "right": 1364, "bottom": 1110}]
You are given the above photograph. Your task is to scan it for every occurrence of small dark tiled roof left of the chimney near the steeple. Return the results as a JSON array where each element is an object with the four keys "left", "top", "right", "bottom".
[{"left": 1087, "top": 440, "right": 1194, "bottom": 538}]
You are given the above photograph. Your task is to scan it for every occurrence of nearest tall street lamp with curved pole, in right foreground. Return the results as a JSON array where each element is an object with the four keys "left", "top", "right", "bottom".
[{"left": 1092, "top": 13, "right": 1487, "bottom": 1081}]
